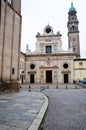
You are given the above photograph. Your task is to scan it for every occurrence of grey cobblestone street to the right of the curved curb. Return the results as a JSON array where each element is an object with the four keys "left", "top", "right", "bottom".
[{"left": 42, "top": 89, "right": 86, "bottom": 130}]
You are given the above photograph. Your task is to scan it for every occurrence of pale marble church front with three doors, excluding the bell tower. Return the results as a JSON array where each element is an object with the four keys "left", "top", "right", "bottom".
[{"left": 22, "top": 25, "right": 76, "bottom": 83}]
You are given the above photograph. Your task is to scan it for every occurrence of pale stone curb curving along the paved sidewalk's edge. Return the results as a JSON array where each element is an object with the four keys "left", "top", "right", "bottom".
[{"left": 28, "top": 94, "right": 48, "bottom": 130}]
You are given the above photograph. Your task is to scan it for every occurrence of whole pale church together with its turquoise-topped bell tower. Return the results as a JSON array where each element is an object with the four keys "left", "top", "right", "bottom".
[{"left": 20, "top": 3, "right": 80, "bottom": 83}]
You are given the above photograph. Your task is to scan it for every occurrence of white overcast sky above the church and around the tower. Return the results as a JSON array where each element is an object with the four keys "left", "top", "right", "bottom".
[{"left": 21, "top": 0, "right": 86, "bottom": 57}]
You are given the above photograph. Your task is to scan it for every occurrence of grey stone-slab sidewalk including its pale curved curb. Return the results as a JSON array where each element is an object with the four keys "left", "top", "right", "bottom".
[{"left": 0, "top": 91, "right": 48, "bottom": 130}]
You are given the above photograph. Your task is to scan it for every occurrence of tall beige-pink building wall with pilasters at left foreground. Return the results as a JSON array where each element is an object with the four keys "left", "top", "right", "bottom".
[{"left": 0, "top": 0, "right": 21, "bottom": 91}]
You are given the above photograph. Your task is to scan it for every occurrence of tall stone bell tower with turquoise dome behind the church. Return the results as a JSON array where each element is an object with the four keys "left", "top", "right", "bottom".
[{"left": 67, "top": 3, "right": 80, "bottom": 57}]
